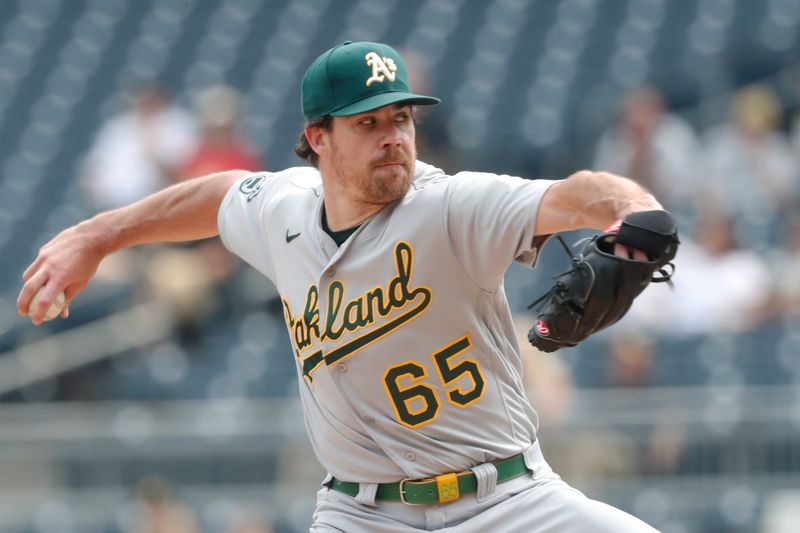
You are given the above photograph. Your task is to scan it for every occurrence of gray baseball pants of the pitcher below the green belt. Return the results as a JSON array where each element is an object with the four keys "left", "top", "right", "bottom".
[{"left": 311, "top": 443, "right": 658, "bottom": 533}]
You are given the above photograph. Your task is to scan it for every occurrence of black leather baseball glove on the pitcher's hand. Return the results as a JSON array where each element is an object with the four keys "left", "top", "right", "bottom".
[{"left": 528, "top": 211, "right": 680, "bottom": 352}]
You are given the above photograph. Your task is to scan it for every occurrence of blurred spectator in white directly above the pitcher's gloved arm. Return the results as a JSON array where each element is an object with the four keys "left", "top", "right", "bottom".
[{"left": 594, "top": 87, "right": 697, "bottom": 208}]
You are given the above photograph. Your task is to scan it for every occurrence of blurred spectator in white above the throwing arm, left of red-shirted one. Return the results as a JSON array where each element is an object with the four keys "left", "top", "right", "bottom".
[{"left": 84, "top": 83, "right": 197, "bottom": 210}]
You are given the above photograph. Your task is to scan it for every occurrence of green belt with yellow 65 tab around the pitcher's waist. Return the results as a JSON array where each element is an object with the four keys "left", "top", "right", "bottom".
[{"left": 331, "top": 453, "right": 528, "bottom": 505}]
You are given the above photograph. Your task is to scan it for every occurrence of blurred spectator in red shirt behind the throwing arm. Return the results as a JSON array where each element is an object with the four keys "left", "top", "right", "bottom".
[{"left": 178, "top": 85, "right": 263, "bottom": 180}]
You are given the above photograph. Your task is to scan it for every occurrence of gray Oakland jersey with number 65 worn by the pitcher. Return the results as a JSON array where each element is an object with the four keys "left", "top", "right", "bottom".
[{"left": 219, "top": 162, "right": 552, "bottom": 482}]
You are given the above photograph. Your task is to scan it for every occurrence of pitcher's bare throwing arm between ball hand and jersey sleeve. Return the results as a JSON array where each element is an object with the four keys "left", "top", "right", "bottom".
[{"left": 84, "top": 170, "right": 248, "bottom": 254}]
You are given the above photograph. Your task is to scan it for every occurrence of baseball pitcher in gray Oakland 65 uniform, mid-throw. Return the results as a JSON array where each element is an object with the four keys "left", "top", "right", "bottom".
[{"left": 17, "top": 42, "right": 677, "bottom": 533}]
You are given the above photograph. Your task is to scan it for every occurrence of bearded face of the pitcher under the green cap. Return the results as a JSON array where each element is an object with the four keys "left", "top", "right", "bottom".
[{"left": 318, "top": 105, "right": 417, "bottom": 205}]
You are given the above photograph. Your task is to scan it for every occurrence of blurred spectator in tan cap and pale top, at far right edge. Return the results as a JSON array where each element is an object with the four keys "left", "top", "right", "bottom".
[{"left": 703, "top": 85, "right": 799, "bottom": 226}]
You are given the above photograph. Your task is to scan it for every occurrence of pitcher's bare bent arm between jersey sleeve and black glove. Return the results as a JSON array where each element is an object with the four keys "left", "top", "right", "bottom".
[{"left": 537, "top": 170, "right": 663, "bottom": 234}]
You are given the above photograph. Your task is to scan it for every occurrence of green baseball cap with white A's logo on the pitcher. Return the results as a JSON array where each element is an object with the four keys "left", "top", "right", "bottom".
[{"left": 301, "top": 41, "right": 441, "bottom": 119}]
